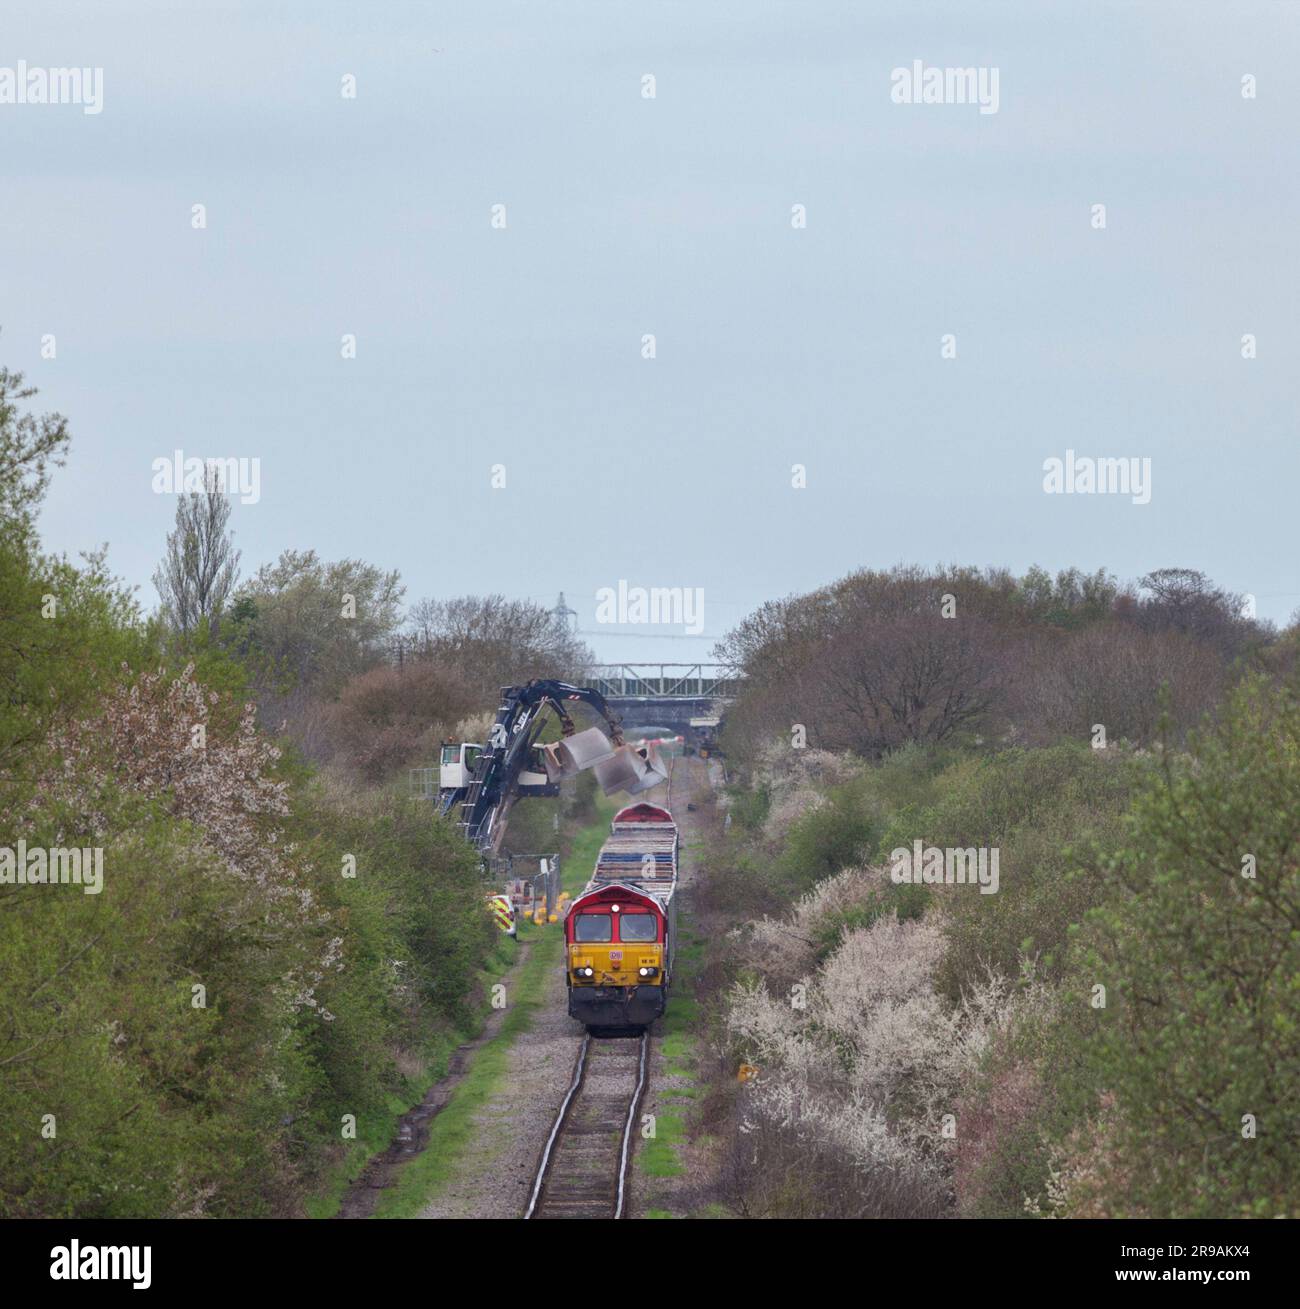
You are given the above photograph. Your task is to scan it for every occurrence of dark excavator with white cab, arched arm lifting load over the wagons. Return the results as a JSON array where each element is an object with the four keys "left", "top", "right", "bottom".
[{"left": 437, "top": 679, "right": 668, "bottom": 859}]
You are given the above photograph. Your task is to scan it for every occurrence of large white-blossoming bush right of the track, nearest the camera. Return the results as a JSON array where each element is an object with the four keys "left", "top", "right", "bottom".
[{"left": 725, "top": 900, "right": 1046, "bottom": 1199}]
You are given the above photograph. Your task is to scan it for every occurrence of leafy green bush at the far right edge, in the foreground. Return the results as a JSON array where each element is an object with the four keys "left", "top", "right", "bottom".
[{"left": 1080, "top": 681, "right": 1300, "bottom": 1217}]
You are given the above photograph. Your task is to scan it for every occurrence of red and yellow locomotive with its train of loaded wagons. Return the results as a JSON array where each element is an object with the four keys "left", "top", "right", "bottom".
[{"left": 564, "top": 804, "right": 677, "bottom": 1028}]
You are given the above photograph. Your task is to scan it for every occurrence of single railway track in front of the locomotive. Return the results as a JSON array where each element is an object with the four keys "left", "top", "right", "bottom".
[{"left": 524, "top": 1031, "right": 649, "bottom": 1219}]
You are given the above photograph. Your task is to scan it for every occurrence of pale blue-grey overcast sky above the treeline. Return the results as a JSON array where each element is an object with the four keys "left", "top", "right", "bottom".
[{"left": 0, "top": 0, "right": 1300, "bottom": 660}]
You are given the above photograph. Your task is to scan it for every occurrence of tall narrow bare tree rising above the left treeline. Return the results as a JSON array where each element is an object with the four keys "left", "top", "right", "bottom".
[{"left": 153, "top": 469, "right": 240, "bottom": 635}]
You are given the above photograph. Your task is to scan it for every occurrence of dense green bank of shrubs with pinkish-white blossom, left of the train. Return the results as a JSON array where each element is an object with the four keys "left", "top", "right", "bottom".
[{"left": 0, "top": 669, "right": 495, "bottom": 1217}]
